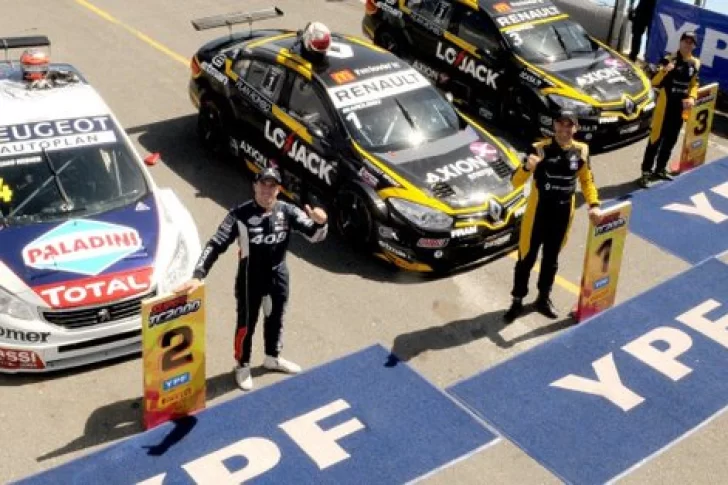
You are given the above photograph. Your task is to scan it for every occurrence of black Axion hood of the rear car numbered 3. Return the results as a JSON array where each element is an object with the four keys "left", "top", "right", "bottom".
[{"left": 540, "top": 49, "right": 647, "bottom": 102}]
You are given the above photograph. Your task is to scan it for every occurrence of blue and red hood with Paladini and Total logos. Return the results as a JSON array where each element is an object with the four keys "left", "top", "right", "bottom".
[{"left": 0, "top": 194, "right": 160, "bottom": 308}]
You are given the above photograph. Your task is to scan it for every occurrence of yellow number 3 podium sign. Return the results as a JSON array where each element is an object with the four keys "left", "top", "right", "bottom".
[{"left": 670, "top": 83, "right": 718, "bottom": 172}]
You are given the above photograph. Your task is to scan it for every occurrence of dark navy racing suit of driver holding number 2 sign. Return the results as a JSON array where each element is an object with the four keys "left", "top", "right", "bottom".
[{"left": 193, "top": 200, "right": 328, "bottom": 366}]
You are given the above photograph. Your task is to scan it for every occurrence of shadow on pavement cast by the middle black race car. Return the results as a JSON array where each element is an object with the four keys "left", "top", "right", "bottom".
[{"left": 126, "top": 115, "right": 427, "bottom": 283}]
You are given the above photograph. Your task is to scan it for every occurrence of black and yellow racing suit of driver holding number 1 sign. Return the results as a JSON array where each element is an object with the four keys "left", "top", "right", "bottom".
[{"left": 511, "top": 138, "right": 601, "bottom": 299}]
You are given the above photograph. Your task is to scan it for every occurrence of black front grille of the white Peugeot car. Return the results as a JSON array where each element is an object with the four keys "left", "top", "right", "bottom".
[{"left": 43, "top": 290, "right": 157, "bottom": 329}]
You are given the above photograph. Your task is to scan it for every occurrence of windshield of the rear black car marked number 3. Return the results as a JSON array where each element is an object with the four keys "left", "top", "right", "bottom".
[{"left": 504, "top": 19, "right": 599, "bottom": 64}]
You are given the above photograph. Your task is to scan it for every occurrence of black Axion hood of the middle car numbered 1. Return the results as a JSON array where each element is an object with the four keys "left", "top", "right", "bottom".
[{"left": 375, "top": 126, "right": 514, "bottom": 208}]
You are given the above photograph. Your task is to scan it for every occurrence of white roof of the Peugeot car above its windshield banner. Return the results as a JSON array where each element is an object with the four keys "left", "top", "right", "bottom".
[{"left": 0, "top": 69, "right": 111, "bottom": 126}]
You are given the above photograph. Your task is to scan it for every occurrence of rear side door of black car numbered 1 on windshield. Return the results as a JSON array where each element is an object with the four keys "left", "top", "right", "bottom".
[{"left": 231, "top": 58, "right": 286, "bottom": 169}]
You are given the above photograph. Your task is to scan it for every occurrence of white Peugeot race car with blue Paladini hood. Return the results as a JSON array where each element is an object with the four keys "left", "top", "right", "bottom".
[{"left": 0, "top": 36, "right": 201, "bottom": 373}]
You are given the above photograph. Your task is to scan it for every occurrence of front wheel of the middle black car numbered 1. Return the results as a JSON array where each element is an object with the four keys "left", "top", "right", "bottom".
[{"left": 336, "top": 188, "right": 374, "bottom": 250}]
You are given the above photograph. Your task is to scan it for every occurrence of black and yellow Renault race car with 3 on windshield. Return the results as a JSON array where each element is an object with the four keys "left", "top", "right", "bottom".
[{"left": 362, "top": 0, "right": 655, "bottom": 150}]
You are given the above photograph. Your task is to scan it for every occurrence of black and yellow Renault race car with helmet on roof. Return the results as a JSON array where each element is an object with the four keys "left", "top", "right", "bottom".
[{"left": 189, "top": 9, "right": 526, "bottom": 272}]
